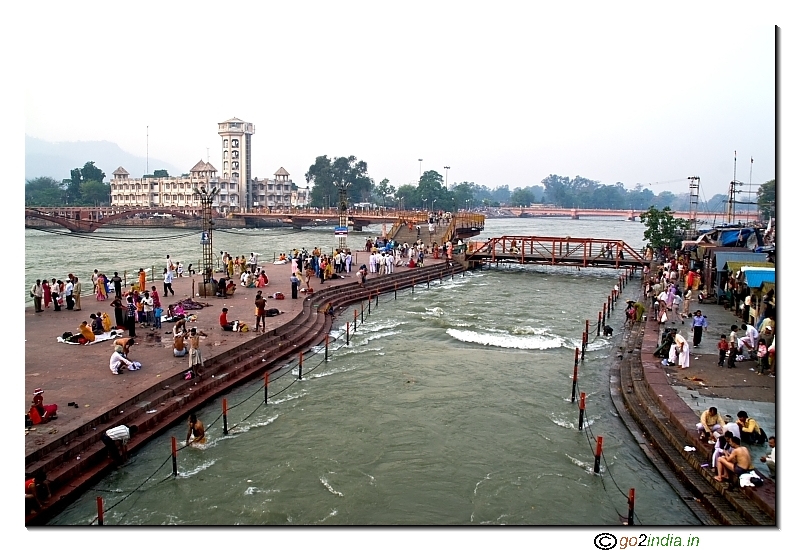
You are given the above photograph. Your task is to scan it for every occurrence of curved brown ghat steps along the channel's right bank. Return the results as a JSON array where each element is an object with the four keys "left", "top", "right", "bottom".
[{"left": 620, "top": 324, "right": 775, "bottom": 525}]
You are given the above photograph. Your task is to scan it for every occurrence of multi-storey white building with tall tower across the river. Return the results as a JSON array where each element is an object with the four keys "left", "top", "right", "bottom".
[{"left": 111, "top": 118, "right": 300, "bottom": 213}]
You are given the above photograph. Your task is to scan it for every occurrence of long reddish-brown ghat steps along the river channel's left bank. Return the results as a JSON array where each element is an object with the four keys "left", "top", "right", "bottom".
[{"left": 26, "top": 264, "right": 463, "bottom": 524}]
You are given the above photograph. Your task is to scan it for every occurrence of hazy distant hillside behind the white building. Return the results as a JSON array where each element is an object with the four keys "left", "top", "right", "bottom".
[{"left": 25, "top": 136, "right": 185, "bottom": 181}]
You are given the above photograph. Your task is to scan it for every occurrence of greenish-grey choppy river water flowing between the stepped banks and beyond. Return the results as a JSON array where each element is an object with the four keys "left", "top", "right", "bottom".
[{"left": 32, "top": 219, "right": 699, "bottom": 526}]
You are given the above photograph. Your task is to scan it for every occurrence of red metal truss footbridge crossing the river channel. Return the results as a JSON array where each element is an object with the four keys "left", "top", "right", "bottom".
[{"left": 465, "top": 235, "right": 648, "bottom": 269}]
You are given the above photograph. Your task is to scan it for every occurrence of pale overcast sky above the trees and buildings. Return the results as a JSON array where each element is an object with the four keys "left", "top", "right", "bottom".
[{"left": 25, "top": 1, "right": 786, "bottom": 199}]
